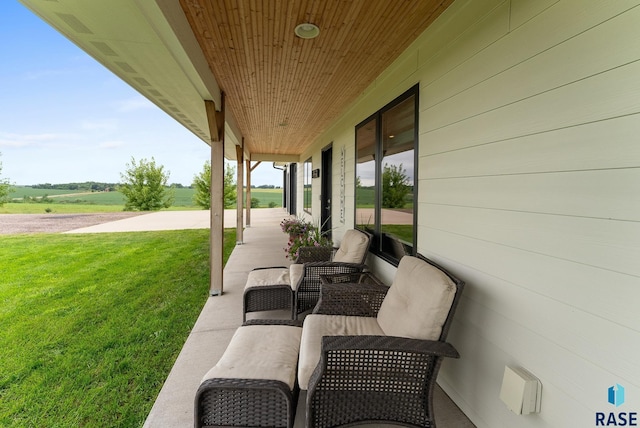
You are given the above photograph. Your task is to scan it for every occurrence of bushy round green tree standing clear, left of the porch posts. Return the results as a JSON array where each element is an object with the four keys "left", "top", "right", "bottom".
[{"left": 118, "top": 157, "right": 174, "bottom": 211}]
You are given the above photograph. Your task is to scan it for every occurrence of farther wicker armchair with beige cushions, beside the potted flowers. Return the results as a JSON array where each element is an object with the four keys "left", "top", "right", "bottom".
[{"left": 289, "top": 229, "right": 371, "bottom": 318}]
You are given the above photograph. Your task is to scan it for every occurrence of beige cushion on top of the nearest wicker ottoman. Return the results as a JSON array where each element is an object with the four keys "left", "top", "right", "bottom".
[{"left": 202, "top": 325, "right": 302, "bottom": 390}]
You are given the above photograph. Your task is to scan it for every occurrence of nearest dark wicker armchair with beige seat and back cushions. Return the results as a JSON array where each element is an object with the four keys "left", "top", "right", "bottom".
[{"left": 298, "top": 256, "right": 464, "bottom": 428}]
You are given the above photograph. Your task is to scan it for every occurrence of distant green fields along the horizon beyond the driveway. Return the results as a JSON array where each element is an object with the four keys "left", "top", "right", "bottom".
[{"left": 0, "top": 186, "right": 282, "bottom": 214}]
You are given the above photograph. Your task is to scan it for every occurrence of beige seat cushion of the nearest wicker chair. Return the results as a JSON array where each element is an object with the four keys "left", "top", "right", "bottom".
[{"left": 298, "top": 314, "right": 384, "bottom": 390}]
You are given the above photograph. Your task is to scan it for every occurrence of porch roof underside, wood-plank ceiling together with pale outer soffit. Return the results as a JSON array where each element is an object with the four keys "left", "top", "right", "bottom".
[{"left": 20, "top": 0, "right": 453, "bottom": 162}]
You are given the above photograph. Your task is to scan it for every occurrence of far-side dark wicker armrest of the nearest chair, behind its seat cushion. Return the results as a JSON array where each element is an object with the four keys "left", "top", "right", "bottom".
[{"left": 313, "top": 283, "right": 389, "bottom": 317}]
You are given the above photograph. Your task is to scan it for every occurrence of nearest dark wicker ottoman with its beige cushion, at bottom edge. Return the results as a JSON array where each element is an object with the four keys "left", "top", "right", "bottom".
[{"left": 195, "top": 320, "right": 302, "bottom": 428}]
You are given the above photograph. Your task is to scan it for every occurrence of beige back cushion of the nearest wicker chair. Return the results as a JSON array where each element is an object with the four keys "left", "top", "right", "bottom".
[{"left": 378, "top": 256, "right": 456, "bottom": 340}]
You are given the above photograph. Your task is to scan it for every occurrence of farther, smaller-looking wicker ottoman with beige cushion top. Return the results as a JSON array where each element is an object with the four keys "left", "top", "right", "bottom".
[{"left": 242, "top": 266, "right": 294, "bottom": 322}]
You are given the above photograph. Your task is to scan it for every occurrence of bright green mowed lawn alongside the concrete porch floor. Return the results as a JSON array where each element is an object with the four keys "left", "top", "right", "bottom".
[{"left": 0, "top": 229, "right": 235, "bottom": 427}]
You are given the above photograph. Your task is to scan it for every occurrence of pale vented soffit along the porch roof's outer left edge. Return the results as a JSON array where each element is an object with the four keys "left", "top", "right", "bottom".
[{"left": 20, "top": 0, "right": 239, "bottom": 150}]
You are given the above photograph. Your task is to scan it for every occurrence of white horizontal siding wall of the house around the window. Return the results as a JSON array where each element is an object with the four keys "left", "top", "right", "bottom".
[{"left": 299, "top": 0, "right": 640, "bottom": 428}]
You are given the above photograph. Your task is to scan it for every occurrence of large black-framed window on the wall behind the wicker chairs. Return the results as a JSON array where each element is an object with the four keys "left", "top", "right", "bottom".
[{"left": 355, "top": 85, "right": 418, "bottom": 262}]
